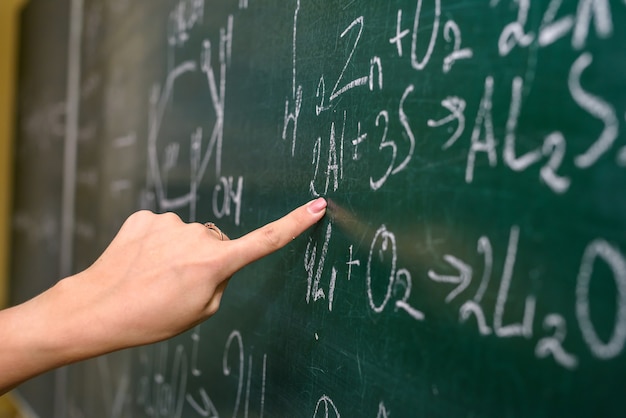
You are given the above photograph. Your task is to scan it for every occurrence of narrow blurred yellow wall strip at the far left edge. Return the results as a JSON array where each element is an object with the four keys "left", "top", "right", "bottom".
[{"left": 0, "top": 0, "right": 25, "bottom": 307}]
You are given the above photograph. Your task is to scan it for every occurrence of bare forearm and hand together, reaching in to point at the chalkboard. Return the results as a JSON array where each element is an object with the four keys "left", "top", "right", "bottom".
[{"left": 0, "top": 198, "right": 326, "bottom": 394}]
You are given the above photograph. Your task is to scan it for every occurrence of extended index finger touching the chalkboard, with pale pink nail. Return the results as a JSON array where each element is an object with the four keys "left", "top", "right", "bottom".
[{"left": 229, "top": 197, "right": 326, "bottom": 273}]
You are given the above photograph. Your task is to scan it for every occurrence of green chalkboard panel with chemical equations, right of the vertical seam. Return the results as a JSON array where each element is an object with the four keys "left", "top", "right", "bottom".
[{"left": 8, "top": 0, "right": 626, "bottom": 418}]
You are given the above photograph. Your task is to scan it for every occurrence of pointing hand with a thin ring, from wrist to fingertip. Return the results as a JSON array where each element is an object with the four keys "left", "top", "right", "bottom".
[{"left": 68, "top": 199, "right": 326, "bottom": 349}]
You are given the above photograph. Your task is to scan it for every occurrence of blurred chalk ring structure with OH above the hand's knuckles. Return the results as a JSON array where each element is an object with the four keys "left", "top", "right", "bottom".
[{"left": 148, "top": 10, "right": 243, "bottom": 225}]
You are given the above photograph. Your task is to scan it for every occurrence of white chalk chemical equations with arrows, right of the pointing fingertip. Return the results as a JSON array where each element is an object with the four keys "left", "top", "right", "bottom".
[{"left": 268, "top": 0, "right": 626, "bottom": 378}]
